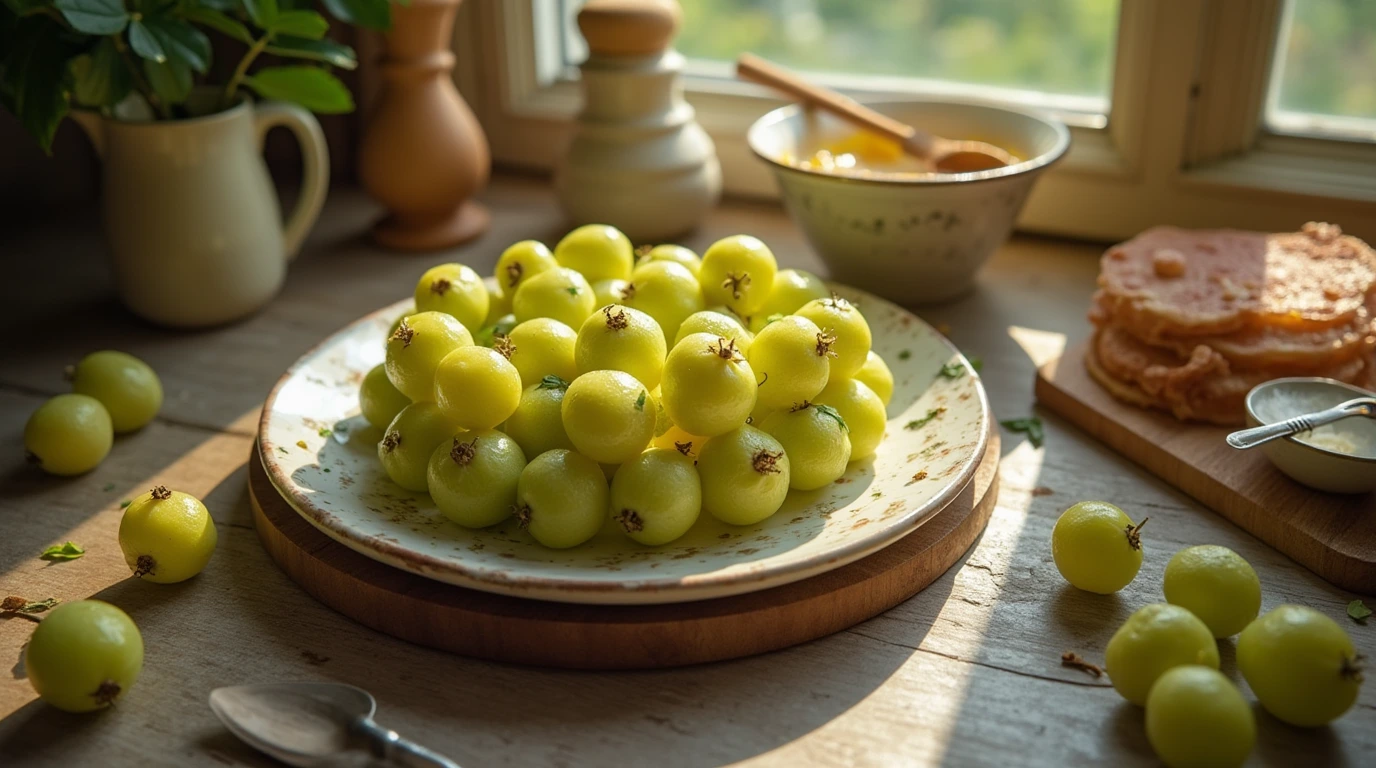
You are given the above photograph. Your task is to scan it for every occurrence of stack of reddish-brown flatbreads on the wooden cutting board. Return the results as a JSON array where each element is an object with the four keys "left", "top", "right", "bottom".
[{"left": 1086, "top": 223, "right": 1376, "bottom": 424}]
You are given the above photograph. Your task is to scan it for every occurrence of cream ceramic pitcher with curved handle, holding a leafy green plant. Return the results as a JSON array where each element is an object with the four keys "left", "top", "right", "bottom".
[{"left": 73, "top": 99, "right": 330, "bottom": 328}]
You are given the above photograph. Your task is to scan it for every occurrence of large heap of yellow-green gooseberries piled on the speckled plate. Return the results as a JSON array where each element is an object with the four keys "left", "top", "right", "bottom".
[{"left": 359, "top": 224, "right": 893, "bottom": 548}]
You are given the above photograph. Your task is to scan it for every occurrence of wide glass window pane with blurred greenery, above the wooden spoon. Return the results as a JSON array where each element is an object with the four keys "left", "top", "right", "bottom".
[{"left": 564, "top": 0, "right": 1119, "bottom": 111}]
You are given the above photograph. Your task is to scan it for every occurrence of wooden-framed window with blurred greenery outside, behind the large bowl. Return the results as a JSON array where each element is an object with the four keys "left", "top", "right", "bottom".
[{"left": 455, "top": 0, "right": 1376, "bottom": 242}]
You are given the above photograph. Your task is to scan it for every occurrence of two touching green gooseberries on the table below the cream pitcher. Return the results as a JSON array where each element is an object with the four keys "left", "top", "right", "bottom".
[{"left": 23, "top": 350, "right": 162, "bottom": 475}]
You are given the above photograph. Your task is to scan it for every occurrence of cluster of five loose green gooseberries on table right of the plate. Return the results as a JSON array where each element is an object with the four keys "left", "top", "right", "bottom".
[{"left": 1051, "top": 501, "right": 1362, "bottom": 768}]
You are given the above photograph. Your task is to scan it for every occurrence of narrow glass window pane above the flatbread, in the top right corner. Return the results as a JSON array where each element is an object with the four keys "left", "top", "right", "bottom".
[{"left": 1267, "top": 0, "right": 1376, "bottom": 140}]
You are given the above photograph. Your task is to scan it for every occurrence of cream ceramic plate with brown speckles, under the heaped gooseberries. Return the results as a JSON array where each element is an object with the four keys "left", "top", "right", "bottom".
[{"left": 259, "top": 286, "right": 989, "bottom": 604}]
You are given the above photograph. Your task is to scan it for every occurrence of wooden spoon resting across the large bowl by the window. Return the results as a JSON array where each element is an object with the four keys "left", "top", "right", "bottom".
[{"left": 736, "top": 54, "right": 1018, "bottom": 173}]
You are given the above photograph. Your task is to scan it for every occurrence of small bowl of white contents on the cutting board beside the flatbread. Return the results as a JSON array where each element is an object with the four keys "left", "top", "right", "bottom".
[{"left": 1247, "top": 377, "right": 1376, "bottom": 493}]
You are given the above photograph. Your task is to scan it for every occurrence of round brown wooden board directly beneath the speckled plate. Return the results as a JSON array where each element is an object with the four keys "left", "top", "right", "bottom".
[{"left": 249, "top": 429, "right": 999, "bottom": 669}]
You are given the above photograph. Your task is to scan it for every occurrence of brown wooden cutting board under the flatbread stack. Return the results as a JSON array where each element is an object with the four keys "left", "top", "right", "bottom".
[{"left": 1036, "top": 341, "right": 1376, "bottom": 595}]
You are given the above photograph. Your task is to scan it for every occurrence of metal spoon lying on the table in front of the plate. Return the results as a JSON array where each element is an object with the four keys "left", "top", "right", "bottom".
[{"left": 211, "top": 683, "right": 458, "bottom": 768}]
